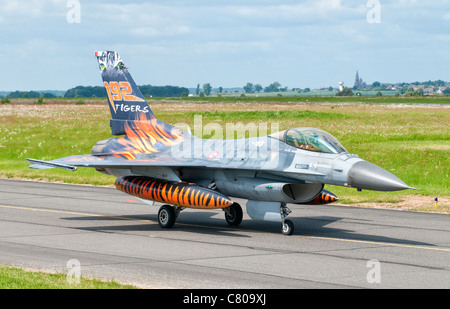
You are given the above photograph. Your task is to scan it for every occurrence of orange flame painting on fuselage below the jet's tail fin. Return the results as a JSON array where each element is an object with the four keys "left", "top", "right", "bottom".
[{"left": 108, "top": 116, "right": 183, "bottom": 160}]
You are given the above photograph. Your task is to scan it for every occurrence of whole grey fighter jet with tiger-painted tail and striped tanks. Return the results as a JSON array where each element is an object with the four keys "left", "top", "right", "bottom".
[{"left": 27, "top": 51, "right": 414, "bottom": 235}]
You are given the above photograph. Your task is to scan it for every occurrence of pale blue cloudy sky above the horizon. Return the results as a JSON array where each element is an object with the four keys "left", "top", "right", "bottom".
[{"left": 0, "top": 0, "right": 450, "bottom": 91}]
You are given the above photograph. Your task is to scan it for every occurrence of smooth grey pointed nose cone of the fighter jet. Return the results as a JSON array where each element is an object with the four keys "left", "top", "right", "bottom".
[{"left": 348, "top": 161, "right": 415, "bottom": 191}]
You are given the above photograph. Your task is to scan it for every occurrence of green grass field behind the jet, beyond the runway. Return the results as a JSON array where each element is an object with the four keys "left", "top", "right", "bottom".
[{"left": 0, "top": 97, "right": 450, "bottom": 213}]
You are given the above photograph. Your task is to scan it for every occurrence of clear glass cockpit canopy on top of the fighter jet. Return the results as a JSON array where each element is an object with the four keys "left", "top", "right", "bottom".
[{"left": 271, "top": 128, "right": 347, "bottom": 154}]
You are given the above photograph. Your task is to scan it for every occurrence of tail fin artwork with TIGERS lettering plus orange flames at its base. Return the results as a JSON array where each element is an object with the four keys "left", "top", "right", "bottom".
[{"left": 95, "top": 51, "right": 183, "bottom": 160}]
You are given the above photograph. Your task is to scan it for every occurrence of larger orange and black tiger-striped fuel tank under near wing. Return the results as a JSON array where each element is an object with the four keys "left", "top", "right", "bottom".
[{"left": 115, "top": 176, "right": 233, "bottom": 209}]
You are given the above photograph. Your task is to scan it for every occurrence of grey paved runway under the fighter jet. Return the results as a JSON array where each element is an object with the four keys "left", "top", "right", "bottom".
[{"left": 0, "top": 180, "right": 450, "bottom": 289}]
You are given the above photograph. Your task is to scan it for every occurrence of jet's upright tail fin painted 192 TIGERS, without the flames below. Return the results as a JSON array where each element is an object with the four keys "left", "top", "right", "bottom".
[{"left": 95, "top": 51, "right": 156, "bottom": 135}]
